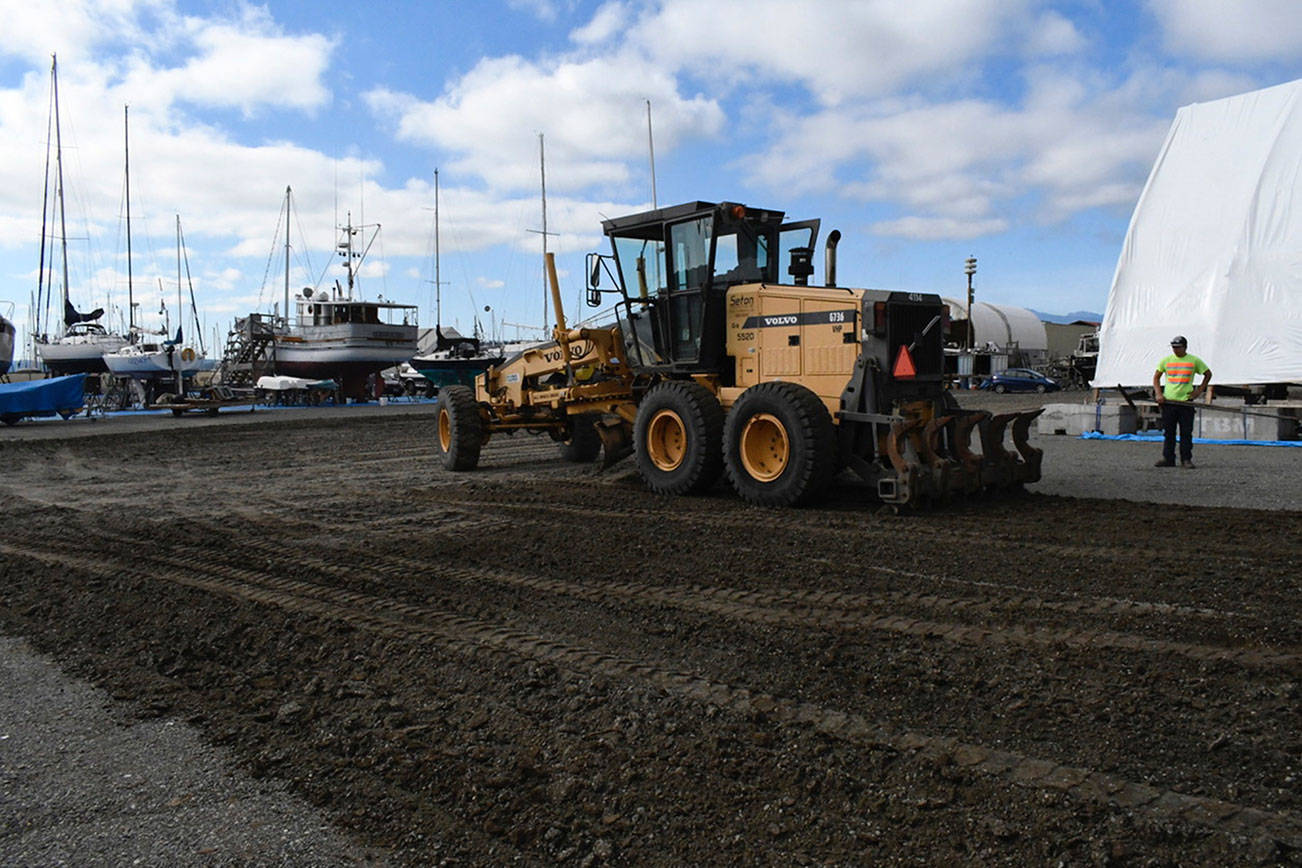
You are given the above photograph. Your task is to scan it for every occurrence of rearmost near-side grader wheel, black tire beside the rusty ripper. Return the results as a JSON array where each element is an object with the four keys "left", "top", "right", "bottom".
[{"left": 724, "top": 383, "right": 836, "bottom": 506}]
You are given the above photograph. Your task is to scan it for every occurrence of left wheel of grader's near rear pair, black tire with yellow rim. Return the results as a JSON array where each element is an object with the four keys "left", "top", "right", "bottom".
[{"left": 633, "top": 380, "right": 724, "bottom": 495}]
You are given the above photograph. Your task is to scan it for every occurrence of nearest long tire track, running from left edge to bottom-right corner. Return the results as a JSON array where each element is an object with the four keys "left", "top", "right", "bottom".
[{"left": 0, "top": 541, "right": 1302, "bottom": 848}]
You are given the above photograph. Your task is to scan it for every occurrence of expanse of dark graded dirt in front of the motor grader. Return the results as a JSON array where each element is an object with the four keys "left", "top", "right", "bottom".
[{"left": 0, "top": 411, "right": 1302, "bottom": 865}]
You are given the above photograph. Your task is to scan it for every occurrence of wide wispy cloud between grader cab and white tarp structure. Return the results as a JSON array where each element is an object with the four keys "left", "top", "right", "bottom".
[{"left": 746, "top": 70, "right": 1169, "bottom": 239}]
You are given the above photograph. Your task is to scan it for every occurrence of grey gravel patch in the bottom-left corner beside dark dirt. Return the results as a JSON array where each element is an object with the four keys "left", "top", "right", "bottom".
[{"left": 0, "top": 636, "right": 383, "bottom": 865}]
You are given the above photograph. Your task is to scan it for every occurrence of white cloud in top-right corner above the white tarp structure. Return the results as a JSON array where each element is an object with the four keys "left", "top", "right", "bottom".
[{"left": 1148, "top": 0, "right": 1302, "bottom": 62}]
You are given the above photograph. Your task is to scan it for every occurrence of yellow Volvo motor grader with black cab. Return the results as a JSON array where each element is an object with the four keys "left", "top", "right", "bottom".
[{"left": 437, "top": 202, "right": 1040, "bottom": 506}]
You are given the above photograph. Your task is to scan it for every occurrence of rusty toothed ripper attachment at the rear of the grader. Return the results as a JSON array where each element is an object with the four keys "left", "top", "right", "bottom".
[{"left": 878, "top": 410, "right": 1043, "bottom": 506}]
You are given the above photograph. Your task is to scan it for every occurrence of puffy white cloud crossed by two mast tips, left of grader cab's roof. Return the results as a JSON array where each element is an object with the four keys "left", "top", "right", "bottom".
[{"left": 367, "top": 52, "right": 723, "bottom": 191}]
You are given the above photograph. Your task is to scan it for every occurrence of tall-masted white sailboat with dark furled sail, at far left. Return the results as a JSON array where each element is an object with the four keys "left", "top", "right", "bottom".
[{"left": 33, "top": 56, "right": 128, "bottom": 375}]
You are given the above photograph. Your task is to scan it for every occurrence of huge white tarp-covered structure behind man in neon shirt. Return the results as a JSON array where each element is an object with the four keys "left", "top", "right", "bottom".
[{"left": 1094, "top": 79, "right": 1302, "bottom": 387}]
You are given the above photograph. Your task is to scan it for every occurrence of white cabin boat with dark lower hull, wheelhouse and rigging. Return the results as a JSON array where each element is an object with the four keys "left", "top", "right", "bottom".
[{"left": 263, "top": 187, "right": 419, "bottom": 398}]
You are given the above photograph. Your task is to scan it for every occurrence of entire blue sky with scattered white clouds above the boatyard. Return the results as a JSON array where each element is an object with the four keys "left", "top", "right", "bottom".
[{"left": 0, "top": 0, "right": 1302, "bottom": 355}]
